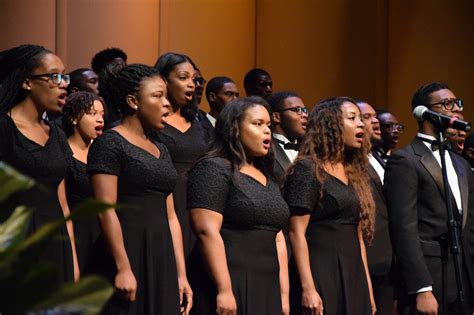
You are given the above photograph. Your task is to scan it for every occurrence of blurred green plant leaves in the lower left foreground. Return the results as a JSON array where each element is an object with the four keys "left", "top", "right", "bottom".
[{"left": 0, "top": 162, "right": 113, "bottom": 314}]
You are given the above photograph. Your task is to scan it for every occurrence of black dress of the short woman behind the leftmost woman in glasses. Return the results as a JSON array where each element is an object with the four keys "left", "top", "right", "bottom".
[{"left": 66, "top": 157, "right": 100, "bottom": 275}]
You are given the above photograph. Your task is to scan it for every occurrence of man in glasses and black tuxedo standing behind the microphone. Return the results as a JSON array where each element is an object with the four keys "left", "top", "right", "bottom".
[{"left": 384, "top": 82, "right": 474, "bottom": 314}]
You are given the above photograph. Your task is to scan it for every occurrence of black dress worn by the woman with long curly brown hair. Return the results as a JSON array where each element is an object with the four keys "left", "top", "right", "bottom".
[{"left": 284, "top": 160, "right": 372, "bottom": 315}]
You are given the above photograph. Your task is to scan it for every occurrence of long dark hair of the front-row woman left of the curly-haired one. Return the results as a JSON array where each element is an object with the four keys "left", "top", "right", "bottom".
[{"left": 203, "top": 96, "right": 274, "bottom": 177}]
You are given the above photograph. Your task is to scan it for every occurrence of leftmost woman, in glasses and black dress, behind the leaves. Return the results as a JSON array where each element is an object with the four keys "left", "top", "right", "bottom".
[{"left": 0, "top": 45, "right": 79, "bottom": 284}]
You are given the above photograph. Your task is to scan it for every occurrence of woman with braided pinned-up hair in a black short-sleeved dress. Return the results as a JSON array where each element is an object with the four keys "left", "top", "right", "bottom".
[{"left": 87, "top": 65, "right": 192, "bottom": 315}]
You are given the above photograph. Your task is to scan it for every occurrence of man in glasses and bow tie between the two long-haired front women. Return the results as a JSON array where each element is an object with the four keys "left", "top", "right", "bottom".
[{"left": 267, "top": 92, "right": 308, "bottom": 183}]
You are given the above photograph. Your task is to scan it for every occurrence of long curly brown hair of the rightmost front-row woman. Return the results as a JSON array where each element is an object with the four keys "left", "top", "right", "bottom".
[{"left": 290, "top": 97, "right": 375, "bottom": 243}]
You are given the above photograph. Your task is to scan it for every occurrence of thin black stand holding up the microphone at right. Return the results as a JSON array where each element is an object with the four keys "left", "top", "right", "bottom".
[{"left": 439, "top": 128, "right": 467, "bottom": 315}]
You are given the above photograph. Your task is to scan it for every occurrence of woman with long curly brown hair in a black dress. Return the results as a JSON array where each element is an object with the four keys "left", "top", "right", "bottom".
[{"left": 284, "top": 97, "right": 375, "bottom": 315}]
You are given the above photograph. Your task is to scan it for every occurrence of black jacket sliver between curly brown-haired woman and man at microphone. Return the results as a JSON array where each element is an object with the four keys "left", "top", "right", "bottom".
[{"left": 366, "top": 165, "right": 393, "bottom": 276}]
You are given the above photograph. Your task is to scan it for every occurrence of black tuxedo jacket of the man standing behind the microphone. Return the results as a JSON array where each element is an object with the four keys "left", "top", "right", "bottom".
[{"left": 384, "top": 139, "right": 474, "bottom": 302}]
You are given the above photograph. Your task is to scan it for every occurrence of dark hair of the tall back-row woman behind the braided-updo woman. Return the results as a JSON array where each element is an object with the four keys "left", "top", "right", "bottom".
[{"left": 155, "top": 52, "right": 198, "bottom": 122}]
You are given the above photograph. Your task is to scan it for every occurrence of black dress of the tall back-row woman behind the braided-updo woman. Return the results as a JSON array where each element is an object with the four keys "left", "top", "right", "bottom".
[{"left": 156, "top": 121, "right": 207, "bottom": 257}]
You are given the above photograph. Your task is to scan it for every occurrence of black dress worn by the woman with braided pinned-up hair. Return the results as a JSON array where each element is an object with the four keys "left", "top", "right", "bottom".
[{"left": 87, "top": 130, "right": 180, "bottom": 315}]
